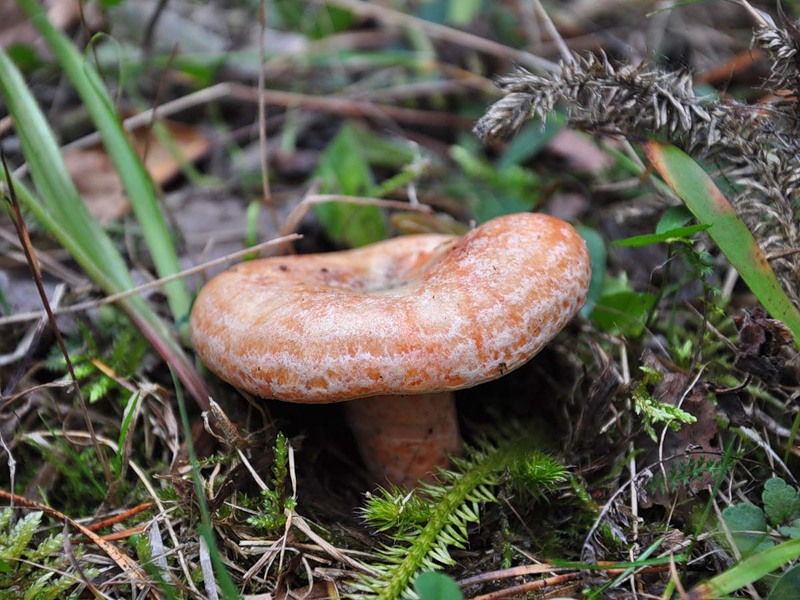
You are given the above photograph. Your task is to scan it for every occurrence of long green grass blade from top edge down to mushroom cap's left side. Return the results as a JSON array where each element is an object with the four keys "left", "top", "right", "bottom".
[{"left": 19, "top": 0, "right": 191, "bottom": 323}]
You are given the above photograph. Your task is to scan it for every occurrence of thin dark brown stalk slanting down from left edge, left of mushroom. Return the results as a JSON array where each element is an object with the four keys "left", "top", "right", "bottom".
[{"left": 0, "top": 152, "right": 112, "bottom": 486}]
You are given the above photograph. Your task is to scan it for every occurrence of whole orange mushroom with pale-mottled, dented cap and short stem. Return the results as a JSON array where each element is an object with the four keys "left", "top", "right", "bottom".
[{"left": 191, "top": 213, "right": 590, "bottom": 486}]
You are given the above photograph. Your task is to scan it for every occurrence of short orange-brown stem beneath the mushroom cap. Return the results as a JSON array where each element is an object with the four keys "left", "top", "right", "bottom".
[{"left": 345, "top": 392, "right": 461, "bottom": 488}]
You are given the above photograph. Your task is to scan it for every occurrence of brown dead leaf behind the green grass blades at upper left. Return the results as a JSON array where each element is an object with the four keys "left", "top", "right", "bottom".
[{"left": 64, "top": 120, "right": 210, "bottom": 224}]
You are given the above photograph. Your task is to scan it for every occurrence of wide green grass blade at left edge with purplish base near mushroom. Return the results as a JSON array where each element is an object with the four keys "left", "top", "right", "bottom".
[{"left": 0, "top": 49, "right": 208, "bottom": 408}]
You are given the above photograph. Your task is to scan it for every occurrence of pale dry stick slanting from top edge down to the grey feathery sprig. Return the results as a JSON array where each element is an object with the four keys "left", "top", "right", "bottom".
[{"left": 325, "top": 0, "right": 559, "bottom": 73}]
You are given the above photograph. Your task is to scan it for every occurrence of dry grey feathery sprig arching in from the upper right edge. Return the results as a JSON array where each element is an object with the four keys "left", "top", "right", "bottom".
[{"left": 475, "top": 15, "right": 800, "bottom": 306}]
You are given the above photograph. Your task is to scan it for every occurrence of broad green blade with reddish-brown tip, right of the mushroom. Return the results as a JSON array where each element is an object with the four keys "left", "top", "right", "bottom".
[{"left": 642, "top": 141, "right": 800, "bottom": 347}]
